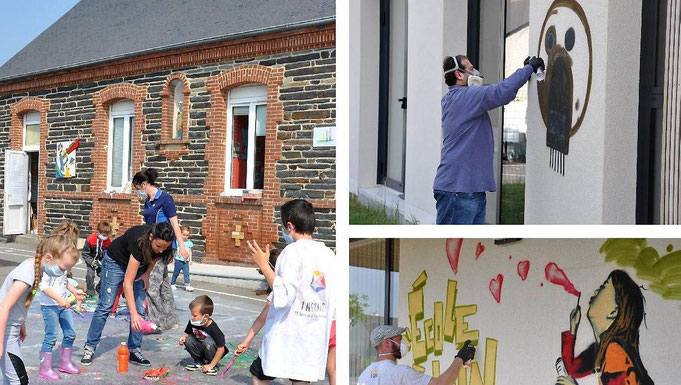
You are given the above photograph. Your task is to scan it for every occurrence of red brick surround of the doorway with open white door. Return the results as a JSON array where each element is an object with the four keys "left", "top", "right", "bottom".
[{"left": 9, "top": 97, "right": 50, "bottom": 234}]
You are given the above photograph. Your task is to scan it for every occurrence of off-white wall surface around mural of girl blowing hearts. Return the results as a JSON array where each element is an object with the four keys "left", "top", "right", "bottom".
[{"left": 398, "top": 239, "right": 681, "bottom": 385}]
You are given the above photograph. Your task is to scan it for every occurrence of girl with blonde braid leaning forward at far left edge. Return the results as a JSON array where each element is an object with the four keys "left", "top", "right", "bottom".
[{"left": 0, "top": 235, "right": 79, "bottom": 385}]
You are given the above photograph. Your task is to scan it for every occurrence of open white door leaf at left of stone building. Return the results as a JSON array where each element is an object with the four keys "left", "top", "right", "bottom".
[{"left": 2, "top": 150, "right": 28, "bottom": 235}]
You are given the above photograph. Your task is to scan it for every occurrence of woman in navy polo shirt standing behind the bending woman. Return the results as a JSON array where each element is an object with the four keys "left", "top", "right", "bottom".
[{"left": 132, "top": 168, "right": 189, "bottom": 330}]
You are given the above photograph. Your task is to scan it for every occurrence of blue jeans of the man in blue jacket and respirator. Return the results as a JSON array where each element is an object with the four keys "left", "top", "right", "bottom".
[{"left": 433, "top": 190, "right": 487, "bottom": 225}]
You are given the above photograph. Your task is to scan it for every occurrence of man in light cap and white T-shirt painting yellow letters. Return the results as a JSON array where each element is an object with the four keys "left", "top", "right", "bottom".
[{"left": 357, "top": 325, "right": 475, "bottom": 385}]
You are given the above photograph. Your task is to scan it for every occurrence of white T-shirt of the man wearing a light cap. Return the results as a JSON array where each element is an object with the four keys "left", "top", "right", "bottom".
[{"left": 357, "top": 360, "right": 432, "bottom": 385}]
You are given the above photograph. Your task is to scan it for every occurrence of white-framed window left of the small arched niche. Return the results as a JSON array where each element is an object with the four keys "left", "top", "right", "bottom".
[{"left": 107, "top": 100, "right": 135, "bottom": 192}]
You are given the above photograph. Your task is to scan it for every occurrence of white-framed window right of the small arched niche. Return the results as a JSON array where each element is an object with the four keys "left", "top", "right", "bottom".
[{"left": 225, "top": 85, "right": 267, "bottom": 195}]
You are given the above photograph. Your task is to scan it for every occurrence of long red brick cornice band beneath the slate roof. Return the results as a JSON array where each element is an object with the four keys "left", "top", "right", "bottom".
[{"left": 0, "top": 23, "right": 336, "bottom": 95}]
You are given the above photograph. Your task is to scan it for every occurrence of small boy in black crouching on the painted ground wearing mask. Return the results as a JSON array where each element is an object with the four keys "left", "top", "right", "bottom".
[{"left": 180, "top": 295, "right": 229, "bottom": 376}]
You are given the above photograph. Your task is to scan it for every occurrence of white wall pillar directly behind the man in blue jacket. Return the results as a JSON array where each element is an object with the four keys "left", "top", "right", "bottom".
[{"left": 405, "top": 0, "right": 468, "bottom": 224}]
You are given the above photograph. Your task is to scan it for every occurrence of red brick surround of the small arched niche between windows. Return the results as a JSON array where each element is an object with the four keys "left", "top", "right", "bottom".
[{"left": 159, "top": 72, "right": 191, "bottom": 160}]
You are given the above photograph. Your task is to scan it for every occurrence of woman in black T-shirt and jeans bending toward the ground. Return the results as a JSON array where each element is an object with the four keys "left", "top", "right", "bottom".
[{"left": 80, "top": 222, "right": 175, "bottom": 366}]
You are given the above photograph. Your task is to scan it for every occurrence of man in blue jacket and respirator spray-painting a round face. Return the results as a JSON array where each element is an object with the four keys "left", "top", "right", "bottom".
[{"left": 433, "top": 55, "right": 544, "bottom": 224}]
